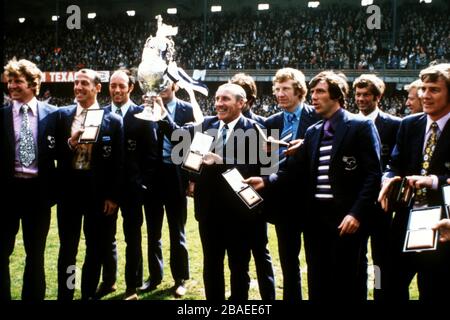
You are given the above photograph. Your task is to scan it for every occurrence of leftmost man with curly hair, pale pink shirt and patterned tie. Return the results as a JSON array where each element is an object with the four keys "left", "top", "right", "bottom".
[{"left": 0, "top": 59, "right": 57, "bottom": 301}]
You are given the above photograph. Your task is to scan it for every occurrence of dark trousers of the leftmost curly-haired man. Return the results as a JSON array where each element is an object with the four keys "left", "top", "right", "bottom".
[{"left": 0, "top": 178, "right": 50, "bottom": 301}]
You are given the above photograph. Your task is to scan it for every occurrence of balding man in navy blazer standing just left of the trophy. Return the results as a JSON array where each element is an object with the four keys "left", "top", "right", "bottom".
[{"left": 96, "top": 69, "right": 157, "bottom": 300}]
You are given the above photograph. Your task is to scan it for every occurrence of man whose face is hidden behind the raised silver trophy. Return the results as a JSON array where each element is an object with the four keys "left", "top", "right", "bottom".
[{"left": 140, "top": 82, "right": 195, "bottom": 297}]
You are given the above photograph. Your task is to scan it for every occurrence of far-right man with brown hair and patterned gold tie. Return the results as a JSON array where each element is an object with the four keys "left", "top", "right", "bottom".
[{"left": 379, "top": 64, "right": 450, "bottom": 302}]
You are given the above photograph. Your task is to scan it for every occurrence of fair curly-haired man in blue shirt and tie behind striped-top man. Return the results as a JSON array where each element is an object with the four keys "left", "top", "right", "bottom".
[{"left": 264, "top": 68, "right": 319, "bottom": 301}]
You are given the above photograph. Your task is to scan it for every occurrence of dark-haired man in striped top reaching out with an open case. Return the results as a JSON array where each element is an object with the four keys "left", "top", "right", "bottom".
[{"left": 244, "top": 71, "right": 381, "bottom": 301}]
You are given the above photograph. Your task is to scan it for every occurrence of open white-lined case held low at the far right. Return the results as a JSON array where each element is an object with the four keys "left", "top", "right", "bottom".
[{"left": 403, "top": 206, "right": 442, "bottom": 252}]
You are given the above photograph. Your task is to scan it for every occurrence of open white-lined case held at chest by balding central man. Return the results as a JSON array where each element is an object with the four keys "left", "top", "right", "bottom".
[{"left": 181, "top": 132, "right": 214, "bottom": 174}]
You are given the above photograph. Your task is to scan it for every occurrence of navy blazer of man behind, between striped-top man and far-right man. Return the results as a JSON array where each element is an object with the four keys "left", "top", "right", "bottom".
[{"left": 375, "top": 110, "right": 402, "bottom": 171}]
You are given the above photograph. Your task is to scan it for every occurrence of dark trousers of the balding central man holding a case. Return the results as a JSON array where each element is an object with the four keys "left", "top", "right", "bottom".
[{"left": 199, "top": 213, "right": 250, "bottom": 301}]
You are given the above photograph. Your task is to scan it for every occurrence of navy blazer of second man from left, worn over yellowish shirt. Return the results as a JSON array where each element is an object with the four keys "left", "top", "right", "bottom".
[{"left": 56, "top": 105, "right": 124, "bottom": 203}]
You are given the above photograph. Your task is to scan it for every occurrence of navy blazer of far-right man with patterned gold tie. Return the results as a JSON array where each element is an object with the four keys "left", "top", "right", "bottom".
[{"left": 386, "top": 113, "right": 450, "bottom": 205}]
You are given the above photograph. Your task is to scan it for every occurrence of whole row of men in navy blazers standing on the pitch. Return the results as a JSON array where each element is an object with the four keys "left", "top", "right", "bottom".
[{"left": 0, "top": 60, "right": 450, "bottom": 301}]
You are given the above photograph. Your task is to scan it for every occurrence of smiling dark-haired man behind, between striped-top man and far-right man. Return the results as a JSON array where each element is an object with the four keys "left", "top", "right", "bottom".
[{"left": 353, "top": 74, "right": 401, "bottom": 300}]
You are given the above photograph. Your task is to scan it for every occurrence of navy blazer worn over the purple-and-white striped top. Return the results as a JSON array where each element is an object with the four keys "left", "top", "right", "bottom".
[{"left": 274, "top": 110, "right": 381, "bottom": 221}]
